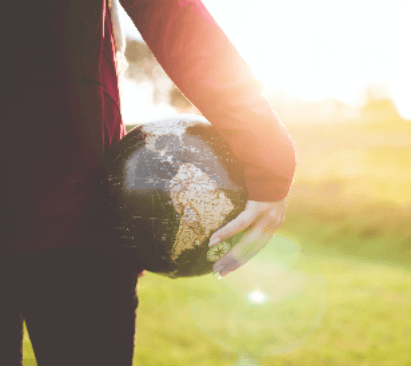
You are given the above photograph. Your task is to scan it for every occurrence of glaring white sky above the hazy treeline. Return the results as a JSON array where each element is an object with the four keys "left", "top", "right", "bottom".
[{"left": 119, "top": 0, "right": 411, "bottom": 120}]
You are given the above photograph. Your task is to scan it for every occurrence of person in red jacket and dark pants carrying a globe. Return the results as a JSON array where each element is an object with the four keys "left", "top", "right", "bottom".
[{"left": 0, "top": 0, "right": 295, "bottom": 366}]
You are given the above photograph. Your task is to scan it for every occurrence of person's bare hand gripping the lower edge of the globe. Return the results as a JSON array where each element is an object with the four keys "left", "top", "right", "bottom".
[{"left": 209, "top": 199, "right": 287, "bottom": 277}]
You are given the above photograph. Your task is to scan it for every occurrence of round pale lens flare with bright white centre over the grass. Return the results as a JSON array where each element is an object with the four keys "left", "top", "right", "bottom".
[{"left": 189, "top": 237, "right": 326, "bottom": 364}]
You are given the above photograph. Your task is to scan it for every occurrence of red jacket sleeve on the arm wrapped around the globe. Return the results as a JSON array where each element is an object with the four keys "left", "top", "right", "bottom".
[{"left": 121, "top": 0, "right": 295, "bottom": 201}]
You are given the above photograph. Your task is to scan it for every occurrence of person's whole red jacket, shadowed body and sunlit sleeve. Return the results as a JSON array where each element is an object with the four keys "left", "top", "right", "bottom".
[{"left": 1, "top": 0, "right": 295, "bottom": 250}]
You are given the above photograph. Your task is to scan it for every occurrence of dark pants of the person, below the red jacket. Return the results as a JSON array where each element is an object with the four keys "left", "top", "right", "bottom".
[{"left": 0, "top": 247, "right": 141, "bottom": 366}]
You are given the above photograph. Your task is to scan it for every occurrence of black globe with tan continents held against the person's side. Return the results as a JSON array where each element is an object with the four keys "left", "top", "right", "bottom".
[{"left": 99, "top": 115, "right": 247, "bottom": 278}]
